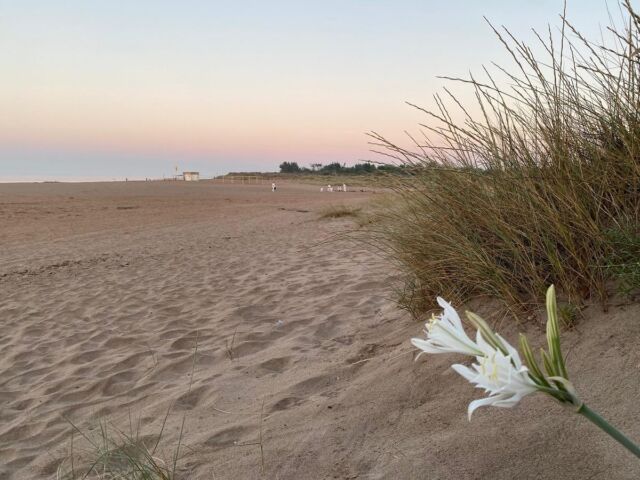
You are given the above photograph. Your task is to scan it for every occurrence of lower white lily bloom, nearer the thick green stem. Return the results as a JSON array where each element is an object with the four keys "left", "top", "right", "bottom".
[{"left": 453, "top": 331, "right": 538, "bottom": 420}]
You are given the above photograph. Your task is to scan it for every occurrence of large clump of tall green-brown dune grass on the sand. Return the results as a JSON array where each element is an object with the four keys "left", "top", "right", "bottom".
[{"left": 371, "top": 3, "right": 640, "bottom": 313}]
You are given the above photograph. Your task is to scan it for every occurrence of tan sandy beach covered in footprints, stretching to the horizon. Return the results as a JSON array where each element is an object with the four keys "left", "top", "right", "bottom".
[{"left": 0, "top": 182, "right": 640, "bottom": 480}]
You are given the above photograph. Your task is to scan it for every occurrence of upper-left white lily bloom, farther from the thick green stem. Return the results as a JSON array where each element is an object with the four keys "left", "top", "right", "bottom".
[{"left": 411, "top": 297, "right": 484, "bottom": 357}]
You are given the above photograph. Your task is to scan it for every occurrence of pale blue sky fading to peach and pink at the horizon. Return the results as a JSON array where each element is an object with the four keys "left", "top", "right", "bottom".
[{"left": 0, "top": 0, "right": 619, "bottom": 181}]
